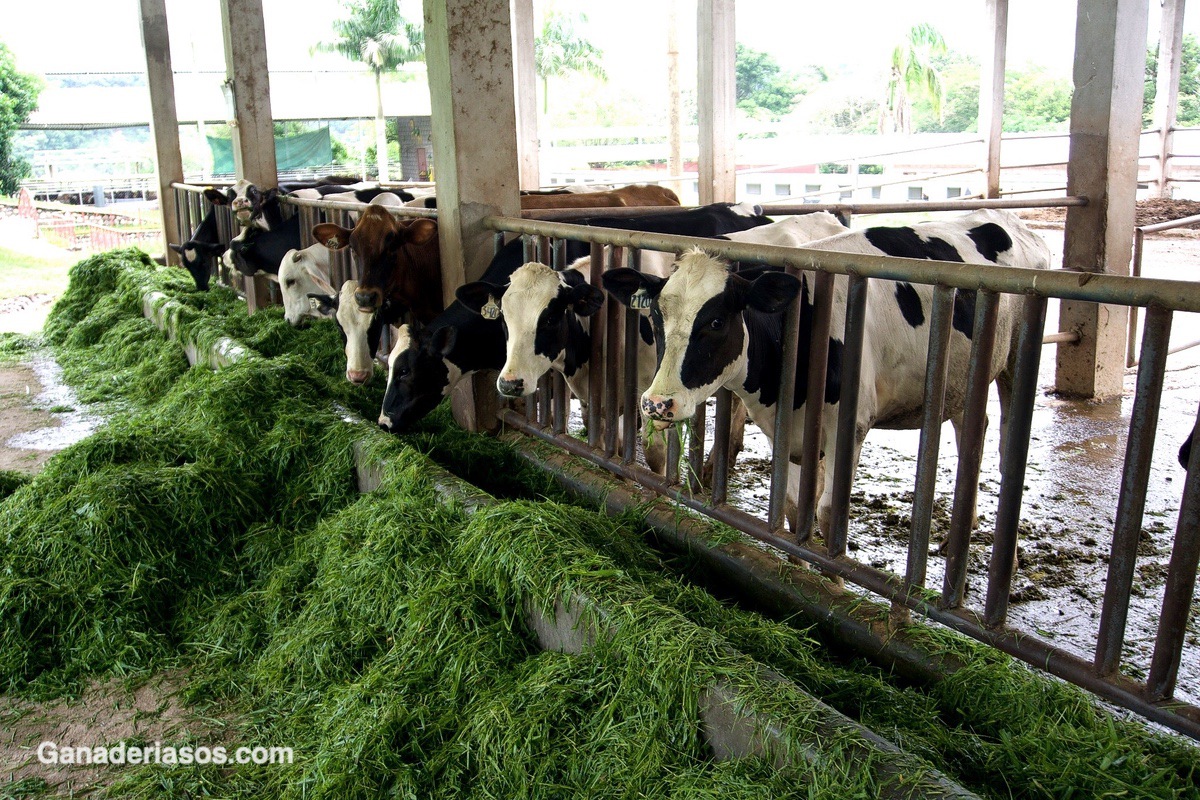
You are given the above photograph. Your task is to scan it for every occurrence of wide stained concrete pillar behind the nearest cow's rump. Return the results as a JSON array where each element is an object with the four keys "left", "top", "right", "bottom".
[{"left": 1055, "top": 0, "right": 1147, "bottom": 398}]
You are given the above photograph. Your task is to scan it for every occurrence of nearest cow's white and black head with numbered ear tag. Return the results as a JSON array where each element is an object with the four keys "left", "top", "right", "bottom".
[{"left": 604, "top": 249, "right": 800, "bottom": 429}]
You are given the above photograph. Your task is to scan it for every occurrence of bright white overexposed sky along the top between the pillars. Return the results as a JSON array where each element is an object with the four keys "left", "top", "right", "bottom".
[{"left": 0, "top": 0, "right": 1200, "bottom": 115}]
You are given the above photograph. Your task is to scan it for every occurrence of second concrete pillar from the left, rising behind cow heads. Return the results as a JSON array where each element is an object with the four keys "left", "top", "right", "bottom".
[{"left": 221, "top": 0, "right": 278, "bottom": 188}]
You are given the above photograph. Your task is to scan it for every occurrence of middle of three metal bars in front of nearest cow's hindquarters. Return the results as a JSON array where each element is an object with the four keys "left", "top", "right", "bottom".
[{"left": 942, "top": 289, "right": 1000, "bottom": 608}]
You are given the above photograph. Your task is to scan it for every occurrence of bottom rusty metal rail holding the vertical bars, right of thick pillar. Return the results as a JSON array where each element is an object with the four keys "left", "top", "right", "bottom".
[{"left": 499, "top": 409, "right": 1200, "bottom": 739}]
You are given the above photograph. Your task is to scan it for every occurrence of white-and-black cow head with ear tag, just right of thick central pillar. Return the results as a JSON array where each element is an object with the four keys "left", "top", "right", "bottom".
[{"left": 456, "top": 263, "right": 604, "bottom": 397}]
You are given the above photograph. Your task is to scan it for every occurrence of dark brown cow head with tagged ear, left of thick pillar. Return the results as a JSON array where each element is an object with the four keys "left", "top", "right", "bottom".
[{"left": 312, "top": 205, "right": 438, "bottom": 311}]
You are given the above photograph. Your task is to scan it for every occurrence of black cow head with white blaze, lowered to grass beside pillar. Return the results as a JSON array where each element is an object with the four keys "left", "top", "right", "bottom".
[{"left": 379, "top": 325, "right": 461, "bottom": 431}]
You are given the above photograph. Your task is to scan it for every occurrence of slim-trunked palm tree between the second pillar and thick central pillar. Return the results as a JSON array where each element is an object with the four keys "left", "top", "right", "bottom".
[{"left": 317, "top": 0, "right": 425, "bottom": 181}]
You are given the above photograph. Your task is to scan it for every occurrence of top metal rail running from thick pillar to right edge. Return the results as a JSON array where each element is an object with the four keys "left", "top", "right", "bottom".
[{"left": 484, "top": 217, "right": 1200, "bottom": 312}]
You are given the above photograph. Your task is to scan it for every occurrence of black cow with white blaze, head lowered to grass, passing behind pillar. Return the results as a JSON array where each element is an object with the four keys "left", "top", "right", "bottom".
[{"left": 379, "top": 203, "right": 770, "bottom": 431}]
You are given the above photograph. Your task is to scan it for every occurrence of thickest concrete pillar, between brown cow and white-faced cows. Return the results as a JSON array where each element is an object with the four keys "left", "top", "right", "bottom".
[{"left": 425, "top": 0, "right": 521, "bottom": 431}]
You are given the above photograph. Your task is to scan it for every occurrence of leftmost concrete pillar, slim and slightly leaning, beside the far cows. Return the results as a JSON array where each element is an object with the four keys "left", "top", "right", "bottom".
[{"left": 140, "top": 0, "right": 182, "bottom": 265}]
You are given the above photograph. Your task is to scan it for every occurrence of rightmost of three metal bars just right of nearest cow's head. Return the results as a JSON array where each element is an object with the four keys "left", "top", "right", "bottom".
[{"left": 826, "top": 275, "right": 868, "bottom": 558}]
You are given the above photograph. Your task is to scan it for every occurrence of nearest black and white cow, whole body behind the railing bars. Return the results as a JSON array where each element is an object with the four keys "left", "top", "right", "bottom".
[{"left": 604, "top": 210, "right": 1050, "bottom": 534}]
